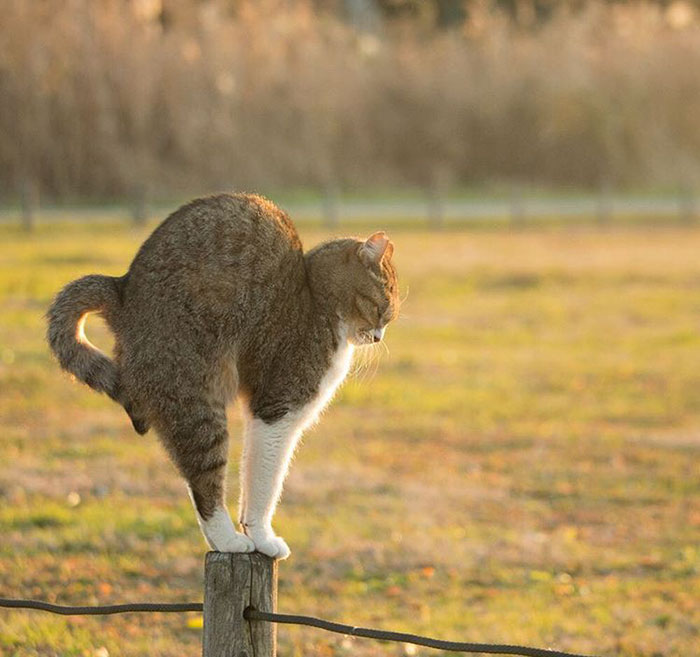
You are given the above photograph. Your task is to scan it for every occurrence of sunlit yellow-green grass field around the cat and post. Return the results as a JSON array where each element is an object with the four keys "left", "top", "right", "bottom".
[{"left": 0, "top": 218, "right": 700, "bottom": 657}]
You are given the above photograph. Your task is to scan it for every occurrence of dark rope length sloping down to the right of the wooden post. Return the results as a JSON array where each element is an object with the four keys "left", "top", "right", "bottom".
[{"left": 243, "top": 607, "right": 590, "bottom": 657}]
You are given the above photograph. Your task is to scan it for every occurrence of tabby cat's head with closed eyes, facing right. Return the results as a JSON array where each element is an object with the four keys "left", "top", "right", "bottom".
[{"left": 344, "top": 231, "right": 399, "bottom": 346}]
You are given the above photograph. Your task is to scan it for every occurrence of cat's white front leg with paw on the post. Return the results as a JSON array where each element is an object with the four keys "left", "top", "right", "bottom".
[{"left": 240, "top": 414, "right": 301, "bottom": 559}]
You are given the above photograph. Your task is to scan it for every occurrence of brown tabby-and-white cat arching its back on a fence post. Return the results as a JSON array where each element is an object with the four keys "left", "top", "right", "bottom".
[{"left": 47, "top": 194, "right": 399, "bottom": 559}]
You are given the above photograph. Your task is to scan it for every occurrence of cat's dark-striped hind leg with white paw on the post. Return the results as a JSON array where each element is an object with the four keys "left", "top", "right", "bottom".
[{"left": 159, "top": 405, "right": 255, "bottom": 552}]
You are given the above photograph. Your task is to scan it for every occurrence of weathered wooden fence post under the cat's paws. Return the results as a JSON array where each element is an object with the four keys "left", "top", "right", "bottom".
[{"left": 202, "top": 552, "right": 277, "bottom": 657}]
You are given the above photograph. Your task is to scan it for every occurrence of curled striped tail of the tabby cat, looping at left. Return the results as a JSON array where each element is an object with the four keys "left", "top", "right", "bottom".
[{"left": 46, "top": 274, "right": 122, "bottom": 403}]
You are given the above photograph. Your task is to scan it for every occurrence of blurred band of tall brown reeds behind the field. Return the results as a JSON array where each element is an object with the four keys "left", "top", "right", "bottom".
[{"left": 0, "top": 0, "right": 700, "bottom": 202}]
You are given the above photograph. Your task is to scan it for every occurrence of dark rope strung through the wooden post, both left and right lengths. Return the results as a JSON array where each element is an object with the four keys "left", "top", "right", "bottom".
[{"left": 0, "top": 598, "right": 590, "bottom": 657}]
